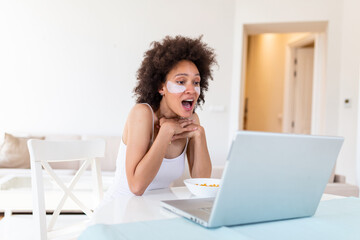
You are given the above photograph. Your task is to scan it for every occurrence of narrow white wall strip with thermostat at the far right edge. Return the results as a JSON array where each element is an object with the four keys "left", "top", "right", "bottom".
[{"left": 336, "top": 0, "right": 360, "bottom": 184}]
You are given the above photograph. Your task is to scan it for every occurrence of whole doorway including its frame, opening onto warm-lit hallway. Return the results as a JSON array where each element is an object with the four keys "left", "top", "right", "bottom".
[{"left": 238, "top": 23, "right": 326, "bottom": 134}]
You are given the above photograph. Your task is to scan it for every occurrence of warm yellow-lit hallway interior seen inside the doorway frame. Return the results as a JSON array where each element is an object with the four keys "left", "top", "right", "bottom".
[{"left": 243, "top": 33, "right": 314, "bottom": 133}]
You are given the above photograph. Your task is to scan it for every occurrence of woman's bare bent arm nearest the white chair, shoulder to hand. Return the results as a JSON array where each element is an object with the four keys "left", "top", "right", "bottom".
[{"left": 124, "top": 104, "right": 197, "bottom": 195}]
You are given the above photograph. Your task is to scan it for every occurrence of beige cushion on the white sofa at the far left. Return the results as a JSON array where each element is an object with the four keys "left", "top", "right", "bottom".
[{"left": 0, "top": 133, "right": 42, "bottom": 168}]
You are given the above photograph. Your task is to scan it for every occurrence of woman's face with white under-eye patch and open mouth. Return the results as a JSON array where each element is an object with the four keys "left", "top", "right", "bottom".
[{"left": 159, "top": 60, "right": 200, "bottom": 118}]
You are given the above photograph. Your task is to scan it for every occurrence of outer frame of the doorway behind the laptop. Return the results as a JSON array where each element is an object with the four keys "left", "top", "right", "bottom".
[{"left": 235, "top": 22, "right": 327, "bottom": 137}]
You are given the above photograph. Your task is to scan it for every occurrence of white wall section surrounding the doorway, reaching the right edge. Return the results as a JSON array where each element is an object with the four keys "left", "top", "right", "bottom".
[{"left": 230, "top": 0, "right": 360, "bottom": 184}]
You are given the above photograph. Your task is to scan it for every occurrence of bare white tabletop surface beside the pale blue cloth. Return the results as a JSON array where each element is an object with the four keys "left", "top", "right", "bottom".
[{"left": 90, "top": 187, "right": 342, "bottom": 225}]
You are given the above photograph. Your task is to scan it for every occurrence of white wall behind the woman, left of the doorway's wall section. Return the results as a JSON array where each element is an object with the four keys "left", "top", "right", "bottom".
[{"left": 0, "top": 0, "right": 235, "bottom": 165}]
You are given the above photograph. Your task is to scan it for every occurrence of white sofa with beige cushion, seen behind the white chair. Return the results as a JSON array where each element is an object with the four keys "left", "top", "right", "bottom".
[{"left": 0, "top": 132, "right": 121, "bottom": 215}]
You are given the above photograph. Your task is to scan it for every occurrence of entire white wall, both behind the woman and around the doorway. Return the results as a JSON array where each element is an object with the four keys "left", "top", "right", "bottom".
[{"left": 0, "top": 0, "right": 360, "bottom": 186}]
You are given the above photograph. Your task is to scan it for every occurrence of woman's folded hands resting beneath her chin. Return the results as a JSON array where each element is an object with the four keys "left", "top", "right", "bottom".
[{"left": 159, "top": 117, "right": 197, "bottom": 136}]
